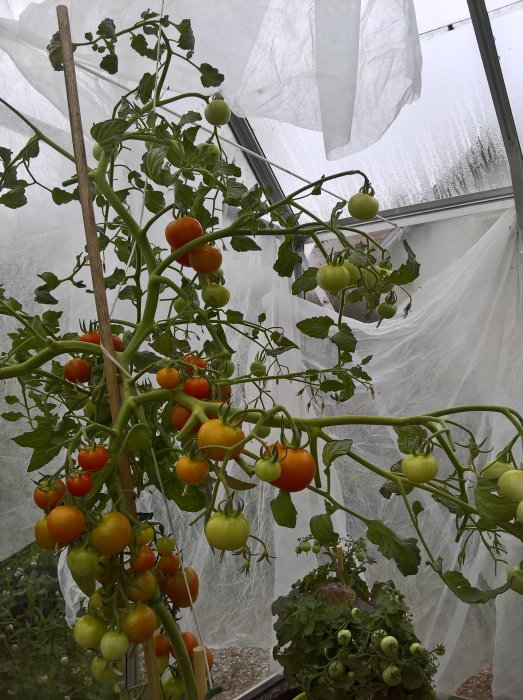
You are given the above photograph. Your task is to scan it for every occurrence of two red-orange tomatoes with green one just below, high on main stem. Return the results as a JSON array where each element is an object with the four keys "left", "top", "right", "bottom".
[{"left": 165, "top": 216, "right": 230, "bottom": 309}]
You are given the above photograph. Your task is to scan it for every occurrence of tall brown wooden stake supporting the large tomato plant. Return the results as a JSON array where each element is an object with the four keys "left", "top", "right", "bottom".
[{"left": 56, "top": 5, "right": 162, "bottom": 700}]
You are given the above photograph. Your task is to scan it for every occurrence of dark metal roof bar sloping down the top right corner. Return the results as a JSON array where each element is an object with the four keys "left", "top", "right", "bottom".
[{"left": 467, "top": 0, "right": 523, "bottom": 230}]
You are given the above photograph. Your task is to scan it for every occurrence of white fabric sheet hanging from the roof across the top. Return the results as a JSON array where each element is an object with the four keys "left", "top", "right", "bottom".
[{"left": 0, "top": 0, "right": 421, "bottom": 158}]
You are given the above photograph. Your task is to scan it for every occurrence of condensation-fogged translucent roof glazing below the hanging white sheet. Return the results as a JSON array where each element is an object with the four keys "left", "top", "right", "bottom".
[{"left": 251, "top": 3, "right": 523, "bottom": 218}]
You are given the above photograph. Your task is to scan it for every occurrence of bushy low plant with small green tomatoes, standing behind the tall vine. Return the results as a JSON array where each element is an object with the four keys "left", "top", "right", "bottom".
[{"left": 272, "top": 537, "right": 444, "bottom": 700}]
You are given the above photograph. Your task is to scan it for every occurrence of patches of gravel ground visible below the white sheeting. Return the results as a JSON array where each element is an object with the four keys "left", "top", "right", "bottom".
[{"left": 207, "top": 647, "right": 492, "bottom": 700}]
